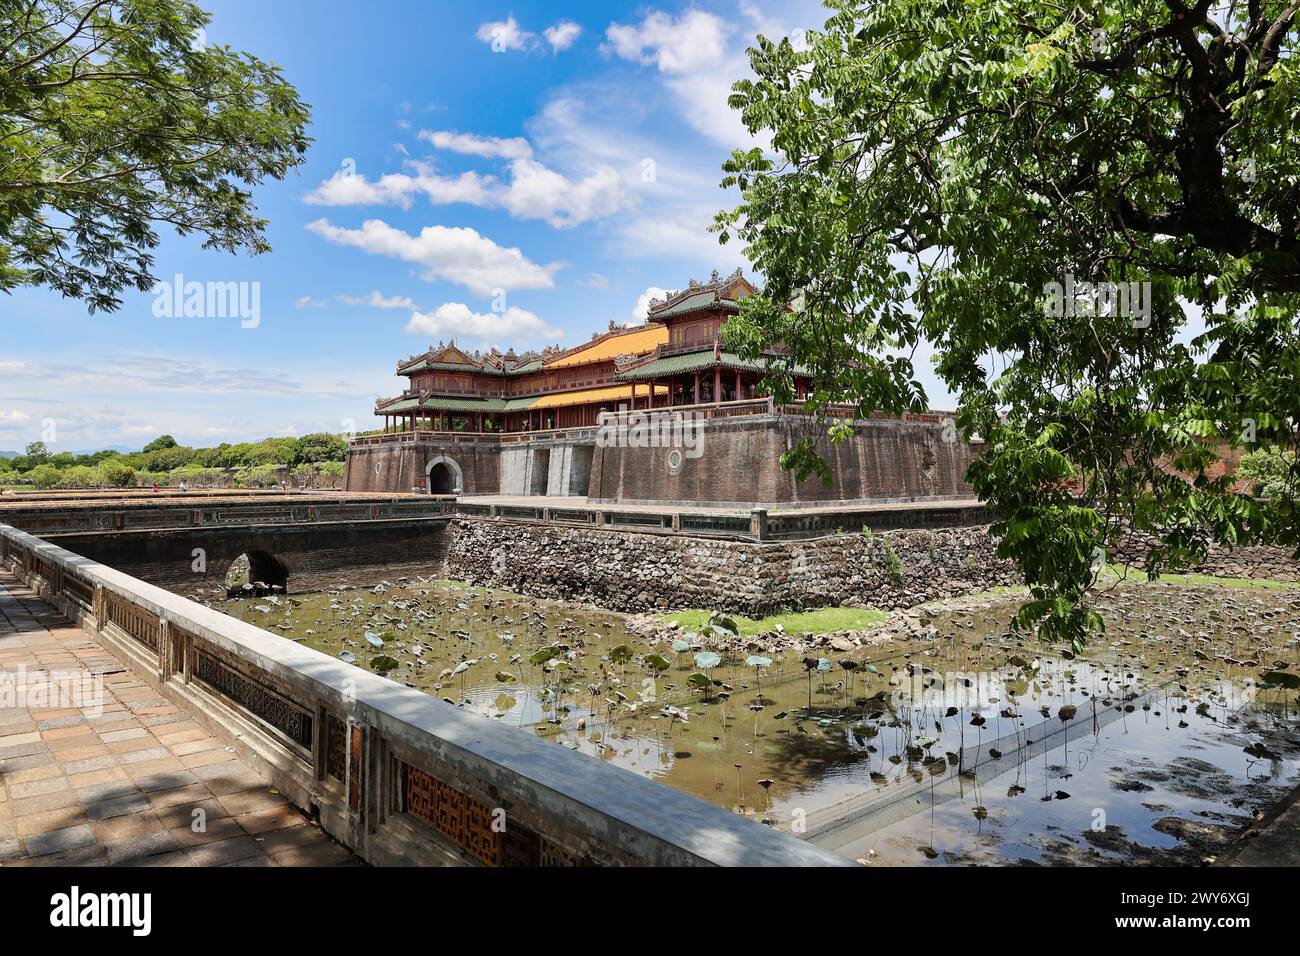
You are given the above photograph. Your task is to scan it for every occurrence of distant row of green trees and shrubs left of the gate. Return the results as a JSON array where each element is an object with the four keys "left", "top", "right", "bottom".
[{"left": 0, "top": 432, "right": 347, "bottom": 488}]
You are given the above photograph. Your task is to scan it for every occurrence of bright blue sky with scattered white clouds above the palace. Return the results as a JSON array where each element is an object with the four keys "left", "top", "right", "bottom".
[{"left": 0, "top": 0, "right": 946, "bottom": 450}]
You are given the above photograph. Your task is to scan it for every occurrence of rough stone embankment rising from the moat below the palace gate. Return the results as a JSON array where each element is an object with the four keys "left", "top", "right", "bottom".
[{"left": 446, "top": 519, "right": 1019, "bottom": 617}]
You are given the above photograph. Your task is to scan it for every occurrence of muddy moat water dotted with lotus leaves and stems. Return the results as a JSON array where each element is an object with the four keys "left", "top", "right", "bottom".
[{"left": 216, "top": 581, "right": 1300, "bottom": 865}]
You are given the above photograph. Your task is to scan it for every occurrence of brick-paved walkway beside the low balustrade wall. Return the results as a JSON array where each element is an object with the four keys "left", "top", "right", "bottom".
[{"left": 0, "top": 570, "right": 358, "bottom": 866}]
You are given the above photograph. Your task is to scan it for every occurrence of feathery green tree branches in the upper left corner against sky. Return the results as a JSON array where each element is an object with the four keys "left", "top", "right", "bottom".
[{"left": 0, "top": 0, "right": 309, "bottom": 312}]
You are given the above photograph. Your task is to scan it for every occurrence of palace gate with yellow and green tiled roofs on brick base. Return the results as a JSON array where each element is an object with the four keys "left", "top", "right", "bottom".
[{"left": 347, "top": 269, "right": 971, "bottom": 507}]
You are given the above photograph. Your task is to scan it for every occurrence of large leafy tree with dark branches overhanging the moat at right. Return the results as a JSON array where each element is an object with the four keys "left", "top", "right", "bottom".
[{"left": 715, "top": 0, "right": 1300, "bottom": 641}]
